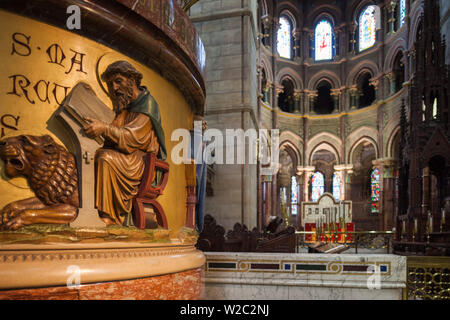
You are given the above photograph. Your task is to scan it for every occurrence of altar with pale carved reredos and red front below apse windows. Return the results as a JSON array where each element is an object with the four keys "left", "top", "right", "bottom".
[{"left": 301, "top": 192, "right": 355, "bottom": 243}]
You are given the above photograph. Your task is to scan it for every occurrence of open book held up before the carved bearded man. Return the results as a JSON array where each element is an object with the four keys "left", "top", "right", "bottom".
[{"left": 62, "top": 82, "right": 114, "bottom": 145}]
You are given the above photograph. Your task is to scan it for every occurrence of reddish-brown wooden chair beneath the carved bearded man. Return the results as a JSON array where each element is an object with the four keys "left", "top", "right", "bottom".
[{"left": 133, "top": 153, "right": 169, "bottom": 229}]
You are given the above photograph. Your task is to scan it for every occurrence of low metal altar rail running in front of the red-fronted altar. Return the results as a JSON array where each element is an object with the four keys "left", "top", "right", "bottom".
[{"left": 295, "top": 231, "right": 395, "bottom": 253}]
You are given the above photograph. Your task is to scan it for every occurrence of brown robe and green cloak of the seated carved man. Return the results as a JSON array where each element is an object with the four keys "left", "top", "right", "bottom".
[{"left": 95, "top": 87, "right": 166, "bottom": 225}]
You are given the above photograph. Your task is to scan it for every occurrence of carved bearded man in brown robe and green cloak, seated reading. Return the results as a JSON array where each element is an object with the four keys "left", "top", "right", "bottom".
[{"left": 84, "top": 61, "right": 166, "bottom": 225}]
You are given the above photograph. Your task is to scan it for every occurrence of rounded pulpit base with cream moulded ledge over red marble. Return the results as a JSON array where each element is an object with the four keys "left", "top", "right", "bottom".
[{"left": 0, "top": 243, "right": 205, "bottom": 300}]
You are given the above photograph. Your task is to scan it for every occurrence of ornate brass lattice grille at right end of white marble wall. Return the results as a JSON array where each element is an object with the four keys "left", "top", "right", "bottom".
[{"left": 403, "top": 256, "right": 450, "bottom": 300}]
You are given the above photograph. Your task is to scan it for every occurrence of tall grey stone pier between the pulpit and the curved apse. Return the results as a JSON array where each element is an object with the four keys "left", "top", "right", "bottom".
[{"left": 189, "top": 0, "right": 258, "bottom": 229}]
